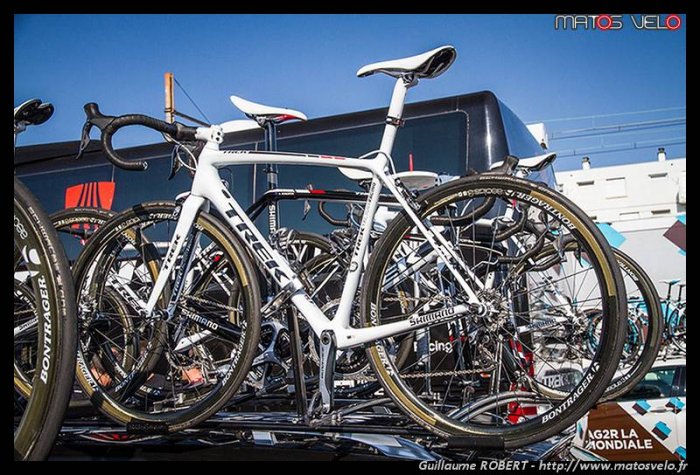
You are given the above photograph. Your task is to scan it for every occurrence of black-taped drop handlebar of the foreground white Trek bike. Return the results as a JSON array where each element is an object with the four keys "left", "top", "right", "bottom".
[{"left": 76, "top": 102, "right": 197, "bottom": 170}]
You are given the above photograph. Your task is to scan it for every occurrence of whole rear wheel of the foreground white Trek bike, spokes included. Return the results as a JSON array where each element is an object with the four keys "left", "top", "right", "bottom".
[{"left": 361, "top": 175, "right": 626, "bottom": 448}]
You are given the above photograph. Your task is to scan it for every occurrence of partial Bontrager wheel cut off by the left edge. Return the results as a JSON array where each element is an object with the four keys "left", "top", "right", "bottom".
[{"left": 14, "top": 178, "right": 77, "bottom": 460}]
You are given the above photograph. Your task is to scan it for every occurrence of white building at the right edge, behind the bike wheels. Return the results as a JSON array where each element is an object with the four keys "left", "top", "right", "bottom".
[{"left": 556, "top": 149, "right": 686, "bottom": 296}]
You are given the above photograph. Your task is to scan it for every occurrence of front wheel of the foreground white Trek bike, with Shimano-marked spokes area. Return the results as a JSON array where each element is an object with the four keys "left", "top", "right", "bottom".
[{"left": 74, "top": 202, "right": 260, "bottom": 432}]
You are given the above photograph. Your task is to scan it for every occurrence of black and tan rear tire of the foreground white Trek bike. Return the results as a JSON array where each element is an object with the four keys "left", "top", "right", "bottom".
[{"left": 361, "top": 174, "right": 626, "bottom": 449}]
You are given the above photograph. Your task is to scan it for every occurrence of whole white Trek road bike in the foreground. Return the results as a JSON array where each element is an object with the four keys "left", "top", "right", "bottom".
[{"left": 76, "top": 46, "right": 625, "bottom": 447}]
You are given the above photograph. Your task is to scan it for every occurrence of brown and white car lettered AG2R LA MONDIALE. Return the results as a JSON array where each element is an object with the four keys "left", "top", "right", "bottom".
[{"left": 574, "top": 359, "right": 686, "bottom": 461}]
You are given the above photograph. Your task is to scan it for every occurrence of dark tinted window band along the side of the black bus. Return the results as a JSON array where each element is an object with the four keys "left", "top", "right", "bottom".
[{"left": 21, "top": 111, "right": 467, "bottom": 238}]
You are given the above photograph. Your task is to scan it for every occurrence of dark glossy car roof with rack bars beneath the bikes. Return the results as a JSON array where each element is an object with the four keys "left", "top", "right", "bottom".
[{"left": 58, "top": 406, "right": 574, "bottom": 461}]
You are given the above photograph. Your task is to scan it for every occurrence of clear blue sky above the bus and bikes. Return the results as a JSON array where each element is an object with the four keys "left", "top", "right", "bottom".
[{"left": 14, "top": 15, "right": 686, "bottom": 169}]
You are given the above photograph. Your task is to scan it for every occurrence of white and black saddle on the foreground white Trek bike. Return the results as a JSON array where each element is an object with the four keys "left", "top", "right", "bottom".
[{"left": 357, "top": 45, "right": 457, "bottom": 78}]
